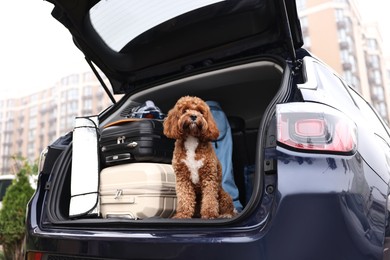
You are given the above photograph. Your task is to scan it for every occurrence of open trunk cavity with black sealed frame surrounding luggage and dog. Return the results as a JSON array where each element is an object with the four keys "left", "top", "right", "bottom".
[{"left": 47, "top": 57, "right": 290, "bottom": 225}]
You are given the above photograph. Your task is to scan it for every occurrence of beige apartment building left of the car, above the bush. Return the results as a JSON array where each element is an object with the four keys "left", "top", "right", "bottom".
[{"left": 0, "top": 72, "right": 115, "bottom": 174}]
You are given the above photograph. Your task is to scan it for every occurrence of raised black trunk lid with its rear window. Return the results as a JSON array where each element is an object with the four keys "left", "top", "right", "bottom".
[{"left": 48, "top": 0, "right": 303, "bottom": 94}]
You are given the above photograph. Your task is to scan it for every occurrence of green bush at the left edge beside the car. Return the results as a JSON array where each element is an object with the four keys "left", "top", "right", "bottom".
[{"left": 0, "top": 159, "right": 37, "bottom": 260}]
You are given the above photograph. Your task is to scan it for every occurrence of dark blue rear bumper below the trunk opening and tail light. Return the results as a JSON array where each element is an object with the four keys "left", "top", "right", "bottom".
[{"left": 26, "top": 150, "right": 387, "bottom": 260}]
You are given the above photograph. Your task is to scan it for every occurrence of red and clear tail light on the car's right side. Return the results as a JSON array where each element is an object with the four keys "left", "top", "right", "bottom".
[{"left": 276, "top": 103, "right": 357, "bottom": 154}]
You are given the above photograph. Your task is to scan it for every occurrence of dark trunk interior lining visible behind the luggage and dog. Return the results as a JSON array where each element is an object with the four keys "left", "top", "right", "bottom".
[{"left": 52, "top": 61, "right": 283, "bottom": 222}]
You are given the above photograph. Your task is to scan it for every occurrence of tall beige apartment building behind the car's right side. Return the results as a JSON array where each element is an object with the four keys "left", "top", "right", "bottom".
[{"left": 297, "top": 0, "right": 390, "bottom": 122}]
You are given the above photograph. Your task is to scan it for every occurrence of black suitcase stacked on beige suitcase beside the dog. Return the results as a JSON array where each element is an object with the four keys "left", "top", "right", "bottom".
[{"left": 70, "top": 101, "right": 176, "bottom": 219}]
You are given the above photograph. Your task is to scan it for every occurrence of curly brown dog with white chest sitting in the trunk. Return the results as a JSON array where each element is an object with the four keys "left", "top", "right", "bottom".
[{"left": 164, "top": 96, "right": 234, "bottom": 219}]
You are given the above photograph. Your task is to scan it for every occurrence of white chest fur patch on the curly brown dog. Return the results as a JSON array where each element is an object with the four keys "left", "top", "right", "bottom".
[{"left": 183, "top": 136, "right": 203, "bottom": 184}]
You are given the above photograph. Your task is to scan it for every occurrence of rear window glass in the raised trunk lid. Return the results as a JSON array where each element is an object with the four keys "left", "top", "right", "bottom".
[{"left": 89, "top": 0, "right": 225, "bottom": 52}]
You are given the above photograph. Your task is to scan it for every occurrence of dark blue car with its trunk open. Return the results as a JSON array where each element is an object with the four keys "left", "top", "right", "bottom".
[{"left": 26, "top": 0, "right": 390, "bottom": 260}]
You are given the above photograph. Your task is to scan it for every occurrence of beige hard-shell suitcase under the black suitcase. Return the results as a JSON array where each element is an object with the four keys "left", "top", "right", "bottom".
[{"left": 100, "top": 163, "right": 176, "bottom": 219}]
